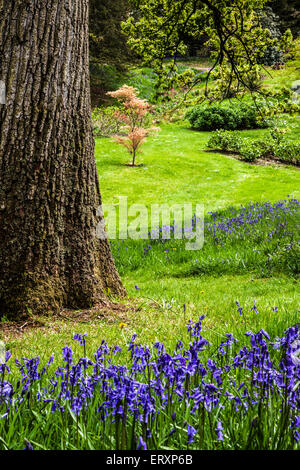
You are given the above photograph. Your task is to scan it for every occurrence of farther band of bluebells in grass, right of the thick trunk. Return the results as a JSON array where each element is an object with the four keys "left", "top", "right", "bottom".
[{"left": 111, "top": 197, "right": 300, "bottom": 271}]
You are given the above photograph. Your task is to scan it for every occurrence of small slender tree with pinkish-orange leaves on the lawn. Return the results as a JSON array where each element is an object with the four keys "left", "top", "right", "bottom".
[{"left": 107, "top": 85, "right": 159, "bottom": 166}]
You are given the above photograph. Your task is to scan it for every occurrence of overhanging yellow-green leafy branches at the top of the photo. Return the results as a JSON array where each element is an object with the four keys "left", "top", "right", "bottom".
[{"left": 122, "top": 0, "right": 294, "bottom": 98}]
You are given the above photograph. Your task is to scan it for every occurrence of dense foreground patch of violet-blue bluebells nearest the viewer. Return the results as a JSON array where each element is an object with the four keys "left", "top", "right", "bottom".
[{"left": 0, "top": 305, "right": 300, "bottom": 450}]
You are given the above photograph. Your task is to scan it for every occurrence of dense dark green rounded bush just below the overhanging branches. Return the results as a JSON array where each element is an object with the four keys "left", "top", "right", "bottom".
[{"left": 185, "top": 103, "right": 269, "bottom": 131}]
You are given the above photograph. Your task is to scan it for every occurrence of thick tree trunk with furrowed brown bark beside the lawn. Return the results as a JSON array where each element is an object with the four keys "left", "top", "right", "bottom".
[{"left": 0, "top": 0, "right": 125, "bottom": 318}]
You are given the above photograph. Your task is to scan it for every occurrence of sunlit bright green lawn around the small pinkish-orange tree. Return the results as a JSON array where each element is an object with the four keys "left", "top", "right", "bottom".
[{"left": 96, "top": 123, "right": 300, "bottom": 212}]
